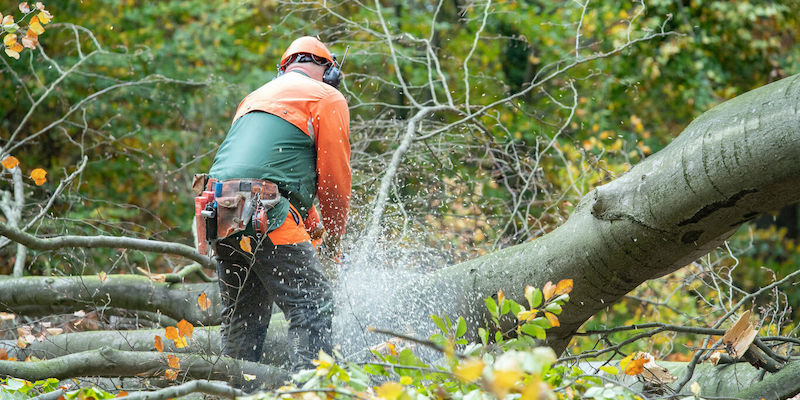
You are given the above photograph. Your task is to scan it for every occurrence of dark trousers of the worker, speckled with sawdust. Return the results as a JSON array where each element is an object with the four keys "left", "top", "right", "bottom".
[{"left": 215, "top": 235, "right": 333, "bottom": 370}]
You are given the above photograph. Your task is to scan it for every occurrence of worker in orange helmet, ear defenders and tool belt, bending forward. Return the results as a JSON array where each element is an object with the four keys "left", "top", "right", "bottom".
[{"left": 195, "top": 36, "right": 351, "bottom": 369}]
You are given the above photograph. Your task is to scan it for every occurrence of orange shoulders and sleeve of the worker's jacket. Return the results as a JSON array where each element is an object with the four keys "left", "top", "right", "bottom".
[{"left": 228, "top": 71, "right": 351, "bottom": 236}]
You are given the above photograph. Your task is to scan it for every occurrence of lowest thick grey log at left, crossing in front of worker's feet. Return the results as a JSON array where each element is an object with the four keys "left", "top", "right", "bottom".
[{"left": 0, "top": 347, "right": 289, "bottom": 388}]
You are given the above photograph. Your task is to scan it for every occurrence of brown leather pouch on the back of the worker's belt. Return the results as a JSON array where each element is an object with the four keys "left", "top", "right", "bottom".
[{"left": 217, "top": 179, "right": 280, "bottom": 239}]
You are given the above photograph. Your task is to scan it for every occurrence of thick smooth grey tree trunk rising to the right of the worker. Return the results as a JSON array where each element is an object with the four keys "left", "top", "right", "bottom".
[{"left": 409, "top": 75, "right": 800, "bottom": 352}]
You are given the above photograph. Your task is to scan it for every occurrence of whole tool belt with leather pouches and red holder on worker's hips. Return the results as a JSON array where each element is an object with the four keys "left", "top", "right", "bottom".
[{"left": 192, "top": 174, "right": 281, "bottom": 254}]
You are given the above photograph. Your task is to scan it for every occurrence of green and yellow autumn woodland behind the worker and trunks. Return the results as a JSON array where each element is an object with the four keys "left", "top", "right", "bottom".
[{"left": 0, "top": 0, "right": 800, "bottom": 398}]
